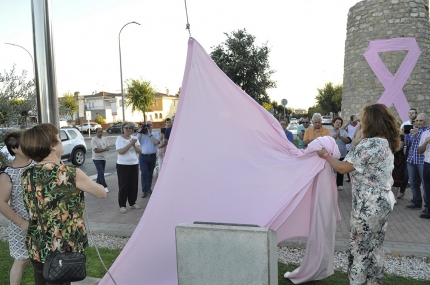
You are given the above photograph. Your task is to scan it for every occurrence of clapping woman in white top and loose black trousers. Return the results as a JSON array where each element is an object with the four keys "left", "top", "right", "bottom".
[{"left": 115, "top": 122, "right": 142, "bottom": 214}]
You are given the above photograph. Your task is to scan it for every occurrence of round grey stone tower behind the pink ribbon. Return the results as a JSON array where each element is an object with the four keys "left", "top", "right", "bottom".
[{"left": 342, "top": 0, "right": 430, "bottom": 120}]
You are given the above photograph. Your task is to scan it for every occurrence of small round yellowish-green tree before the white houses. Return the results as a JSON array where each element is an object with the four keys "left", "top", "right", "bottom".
[{"left": 125, "top": 79, "right": 157, "bottom": 123}]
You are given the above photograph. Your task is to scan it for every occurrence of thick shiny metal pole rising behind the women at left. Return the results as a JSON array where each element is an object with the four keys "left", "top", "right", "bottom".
[{"left": 31, "top": 0, "right": 60, "bottom": 127}]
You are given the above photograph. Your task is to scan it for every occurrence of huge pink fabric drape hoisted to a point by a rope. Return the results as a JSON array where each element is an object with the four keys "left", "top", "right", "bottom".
[{"left": 100, "top": 38, "right": 340, "bottom": 285}]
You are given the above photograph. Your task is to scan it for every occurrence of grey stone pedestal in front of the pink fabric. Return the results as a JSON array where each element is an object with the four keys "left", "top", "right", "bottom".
[{"left": 176, "top": 224, "right": 278, "bottom": 285}]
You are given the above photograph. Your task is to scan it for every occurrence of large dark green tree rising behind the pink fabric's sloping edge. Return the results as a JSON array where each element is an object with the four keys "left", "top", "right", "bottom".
[{"left": 211, "top": 29, "right": 276, "bottom": 105}]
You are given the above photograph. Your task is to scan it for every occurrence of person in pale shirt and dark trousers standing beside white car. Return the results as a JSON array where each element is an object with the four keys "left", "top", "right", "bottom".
[{"left": 91, "top": 128, "right": 110, "bottom": 192}]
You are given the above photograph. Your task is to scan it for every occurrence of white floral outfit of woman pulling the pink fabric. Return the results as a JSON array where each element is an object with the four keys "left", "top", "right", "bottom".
[{"left": 345, "top": 138, "right": 394, "bottom": 284}]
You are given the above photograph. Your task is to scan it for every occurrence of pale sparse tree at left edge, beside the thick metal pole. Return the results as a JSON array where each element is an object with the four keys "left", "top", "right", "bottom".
[{"left": 0, "top": 65, "right": 37, "bottom": 125}]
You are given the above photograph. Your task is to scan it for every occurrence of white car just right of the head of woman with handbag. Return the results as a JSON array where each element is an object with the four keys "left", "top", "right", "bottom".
[{"left": 60, "top": 128, "right": 87, "bottom": 166}]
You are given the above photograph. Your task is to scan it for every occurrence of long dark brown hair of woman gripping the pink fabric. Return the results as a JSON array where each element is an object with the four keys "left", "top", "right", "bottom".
[{"left": 361, "top": 104, "right": 400, "bottom": 153}]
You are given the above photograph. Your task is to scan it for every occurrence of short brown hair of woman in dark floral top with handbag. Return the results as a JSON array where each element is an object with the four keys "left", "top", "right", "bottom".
[{"left": 21, "top": 124, "right": 61, "bottom": 162}]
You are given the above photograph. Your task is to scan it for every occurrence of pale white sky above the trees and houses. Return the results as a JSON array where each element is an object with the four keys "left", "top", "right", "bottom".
[{"left": 0, "top": 0, "right": 359, "bottom": 109}]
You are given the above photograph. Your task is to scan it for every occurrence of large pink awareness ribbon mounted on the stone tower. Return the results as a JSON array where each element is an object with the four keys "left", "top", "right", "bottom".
[{"left": 364, "top": 38, "right": 421, "bottom": 122}]
